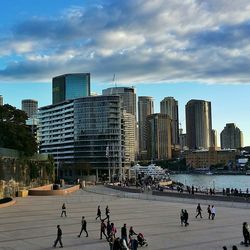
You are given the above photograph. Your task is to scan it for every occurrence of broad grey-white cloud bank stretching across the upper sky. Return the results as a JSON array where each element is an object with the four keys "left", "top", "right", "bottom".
[{"left": 0, "top": 0, "right": 250, "bottom": 83}]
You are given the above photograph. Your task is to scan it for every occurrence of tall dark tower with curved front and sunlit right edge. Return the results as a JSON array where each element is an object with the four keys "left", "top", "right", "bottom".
[{"left": 186, "top": 100, "right": 212, "bottom": 149}]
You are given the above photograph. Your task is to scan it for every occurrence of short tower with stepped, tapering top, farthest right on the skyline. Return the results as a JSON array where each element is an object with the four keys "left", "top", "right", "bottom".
[{"left": 220, "top": 123, "right": 243, "bottom": 149}]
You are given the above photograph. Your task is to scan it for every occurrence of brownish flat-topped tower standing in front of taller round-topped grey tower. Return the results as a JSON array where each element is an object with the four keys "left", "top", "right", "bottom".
[{"left": 147, "top": 114, "right": 172, "bottom": 160}]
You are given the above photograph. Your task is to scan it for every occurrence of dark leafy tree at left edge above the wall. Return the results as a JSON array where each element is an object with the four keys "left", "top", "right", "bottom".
[{"left": 0, "top": 104, "right": 37, "bottom": 156}]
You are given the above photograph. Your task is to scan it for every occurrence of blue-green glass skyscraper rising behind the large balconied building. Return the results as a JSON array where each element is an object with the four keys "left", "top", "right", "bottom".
[{"left": 52, "top": 73, "right": 90, "bottom": 104}]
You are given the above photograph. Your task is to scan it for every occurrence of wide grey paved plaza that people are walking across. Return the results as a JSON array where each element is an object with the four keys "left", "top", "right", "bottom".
[{"left": 0, "top": 186, "right": 250, "bottom": 250}]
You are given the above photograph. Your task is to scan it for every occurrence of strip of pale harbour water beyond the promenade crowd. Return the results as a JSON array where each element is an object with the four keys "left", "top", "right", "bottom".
[{"left": 170, "top": 174, "right": 250, "bottom": 192}]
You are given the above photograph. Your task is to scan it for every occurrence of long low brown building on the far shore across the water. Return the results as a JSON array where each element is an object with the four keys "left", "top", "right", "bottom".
[{"left": 184, "top": 147, "right": 239, "bottom": 169}]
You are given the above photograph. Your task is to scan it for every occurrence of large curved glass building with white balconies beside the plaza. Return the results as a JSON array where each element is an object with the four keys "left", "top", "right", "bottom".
[{"left": 39, "top": 96, "right": 124, "bottom": 179}]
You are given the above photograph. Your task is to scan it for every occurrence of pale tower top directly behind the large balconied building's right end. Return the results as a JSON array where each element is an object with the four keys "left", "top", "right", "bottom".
[{"left": 102, "top": 87, "right": 136, "bottom": 120}]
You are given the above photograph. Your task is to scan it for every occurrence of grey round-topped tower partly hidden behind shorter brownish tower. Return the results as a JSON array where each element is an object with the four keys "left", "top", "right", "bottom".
[{"left": 161, "top": 97, "right": 180, "bottom": 145}]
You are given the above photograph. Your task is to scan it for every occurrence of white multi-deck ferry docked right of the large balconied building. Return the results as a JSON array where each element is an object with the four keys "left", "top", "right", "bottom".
[{"left": 130, "top": 163, "right": 169, "bottom": 179}]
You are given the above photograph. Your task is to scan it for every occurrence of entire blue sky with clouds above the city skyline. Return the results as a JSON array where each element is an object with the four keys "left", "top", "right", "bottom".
[{"left": 0, "top": 0, "right": 250, "bottom": 145}]
